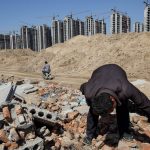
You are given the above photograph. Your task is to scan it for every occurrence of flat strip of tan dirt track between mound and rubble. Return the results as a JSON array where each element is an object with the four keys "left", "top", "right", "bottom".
[{"left": 0, "top": 67, "right": 150, "bottom": 97}]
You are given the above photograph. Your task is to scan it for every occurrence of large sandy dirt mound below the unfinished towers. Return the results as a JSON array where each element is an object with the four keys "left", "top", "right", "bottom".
[{"left": 0, "top": 33, "right": 150, "bottom": 79}]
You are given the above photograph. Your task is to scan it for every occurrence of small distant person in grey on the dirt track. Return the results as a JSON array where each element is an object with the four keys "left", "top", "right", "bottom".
[{"left": 42, "top": 61, "right": 51, "bottom": 79}]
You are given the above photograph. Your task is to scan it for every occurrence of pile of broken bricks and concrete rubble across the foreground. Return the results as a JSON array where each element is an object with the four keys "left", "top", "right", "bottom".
[{"left": 0, "top": 81, "right": 150, "bottom": 150}]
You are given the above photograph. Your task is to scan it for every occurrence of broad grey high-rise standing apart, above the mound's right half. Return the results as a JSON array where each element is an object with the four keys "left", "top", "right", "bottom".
[{"left": 111, "top": 10, "right": 131, "bottom": 34}]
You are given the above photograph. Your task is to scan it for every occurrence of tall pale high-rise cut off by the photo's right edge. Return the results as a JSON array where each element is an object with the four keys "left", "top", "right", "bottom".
[{"left": 144, "top": 3, "right": 150, "bottom": 32}]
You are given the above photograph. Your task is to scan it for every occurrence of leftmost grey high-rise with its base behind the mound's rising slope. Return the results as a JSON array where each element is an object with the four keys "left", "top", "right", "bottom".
[{"left": 51, "top": 19, "right": 64, "bottom": 45}]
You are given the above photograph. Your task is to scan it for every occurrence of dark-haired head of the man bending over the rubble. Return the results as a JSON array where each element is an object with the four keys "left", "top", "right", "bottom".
[{"left": 92, "top": 93, "right": 116, "bottom": 116}]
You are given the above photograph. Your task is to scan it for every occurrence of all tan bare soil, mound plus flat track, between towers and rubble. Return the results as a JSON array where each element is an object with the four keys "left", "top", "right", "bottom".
[{"left": 0, "top": 33, "right": 150, "bottom": 93}]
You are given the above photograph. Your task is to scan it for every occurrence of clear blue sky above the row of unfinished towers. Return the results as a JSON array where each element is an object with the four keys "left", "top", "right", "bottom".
[{"left": 0, "top": 0, "right": 144, "bottom": 33}]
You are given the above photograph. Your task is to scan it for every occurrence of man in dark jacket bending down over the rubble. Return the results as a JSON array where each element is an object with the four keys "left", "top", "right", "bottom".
[{"left": 80, "top": 64, "right": 150, "bottom": 144}]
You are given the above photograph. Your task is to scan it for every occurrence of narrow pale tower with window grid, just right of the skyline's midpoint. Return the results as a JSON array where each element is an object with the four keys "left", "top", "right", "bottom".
[{"left": 85, "top": 16, "right": 94, "bottom": 36}]
